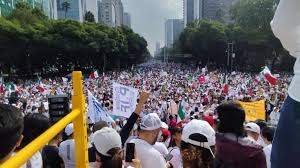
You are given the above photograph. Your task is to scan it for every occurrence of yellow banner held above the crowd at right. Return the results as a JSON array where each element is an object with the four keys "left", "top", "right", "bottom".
[{"left": 239, "top": 100, "right": 266, "bottom": 122}]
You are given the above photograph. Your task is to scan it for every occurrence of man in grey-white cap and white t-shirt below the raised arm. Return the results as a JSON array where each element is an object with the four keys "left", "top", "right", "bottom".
[{"left": 130, "top": 113, "right": 166, "bottom": 168}]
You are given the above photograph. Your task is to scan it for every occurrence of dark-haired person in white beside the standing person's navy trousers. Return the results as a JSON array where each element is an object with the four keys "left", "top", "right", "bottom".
[{"left": 261, "top": 126, "right": 275, "bottom": 168}]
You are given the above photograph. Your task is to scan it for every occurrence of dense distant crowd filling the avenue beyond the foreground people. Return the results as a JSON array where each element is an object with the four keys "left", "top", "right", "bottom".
[{"left": 0, "top": 63, "right": 291, "bottom": 125}]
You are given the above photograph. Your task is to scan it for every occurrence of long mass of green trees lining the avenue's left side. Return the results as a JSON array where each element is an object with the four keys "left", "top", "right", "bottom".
[{"left": 0, "top": 3, "right": 149, "bottom": 75}]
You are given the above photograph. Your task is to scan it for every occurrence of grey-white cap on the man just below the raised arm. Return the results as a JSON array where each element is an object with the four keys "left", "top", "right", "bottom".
[{"left": 140, "top": 113, "right": 162, "bottom": 131}]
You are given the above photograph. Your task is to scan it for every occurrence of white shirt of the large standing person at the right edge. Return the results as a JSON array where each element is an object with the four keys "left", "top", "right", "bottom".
[{"left": 271, "top": 0, "right": 300, "bottom": 102}]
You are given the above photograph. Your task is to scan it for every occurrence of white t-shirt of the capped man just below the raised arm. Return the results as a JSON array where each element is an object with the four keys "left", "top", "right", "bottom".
[{"left": 130, "top": 139, "right": 166, "bottom": 168}]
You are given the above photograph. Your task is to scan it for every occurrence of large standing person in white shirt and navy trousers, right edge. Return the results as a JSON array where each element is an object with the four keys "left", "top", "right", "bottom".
[{"left": 271, "top": 0, "right": 300, "bottom": 168}]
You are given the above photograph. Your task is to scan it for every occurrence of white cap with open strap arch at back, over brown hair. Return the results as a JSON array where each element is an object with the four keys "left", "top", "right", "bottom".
[{"left": 181, "top": 119, "right": 216, "bottom": 156}]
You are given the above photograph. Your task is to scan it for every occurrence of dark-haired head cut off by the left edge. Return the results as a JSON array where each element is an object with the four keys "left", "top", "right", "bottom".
[{"left": 0, "top": 104, "right": 24, "bottom": 160}]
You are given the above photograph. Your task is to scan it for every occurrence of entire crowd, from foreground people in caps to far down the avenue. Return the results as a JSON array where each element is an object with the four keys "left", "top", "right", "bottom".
[{"left": 1, "top": 63, "right": 290, "bottom": 168}]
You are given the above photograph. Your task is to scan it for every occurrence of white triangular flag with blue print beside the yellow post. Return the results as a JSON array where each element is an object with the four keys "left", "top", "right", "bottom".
[{"left": 88, "top": 90, "right": 114, "bottom": 124}]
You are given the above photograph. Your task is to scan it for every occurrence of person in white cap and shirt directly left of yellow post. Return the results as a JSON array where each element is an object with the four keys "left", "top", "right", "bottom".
[{"left": 58, "top": 123, "right": 75, "bottom": 168}]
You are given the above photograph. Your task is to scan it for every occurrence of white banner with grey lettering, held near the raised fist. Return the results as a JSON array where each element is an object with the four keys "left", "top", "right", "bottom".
[{"left": 113, "top": 83, "right": 138, "bottom": 118}]
